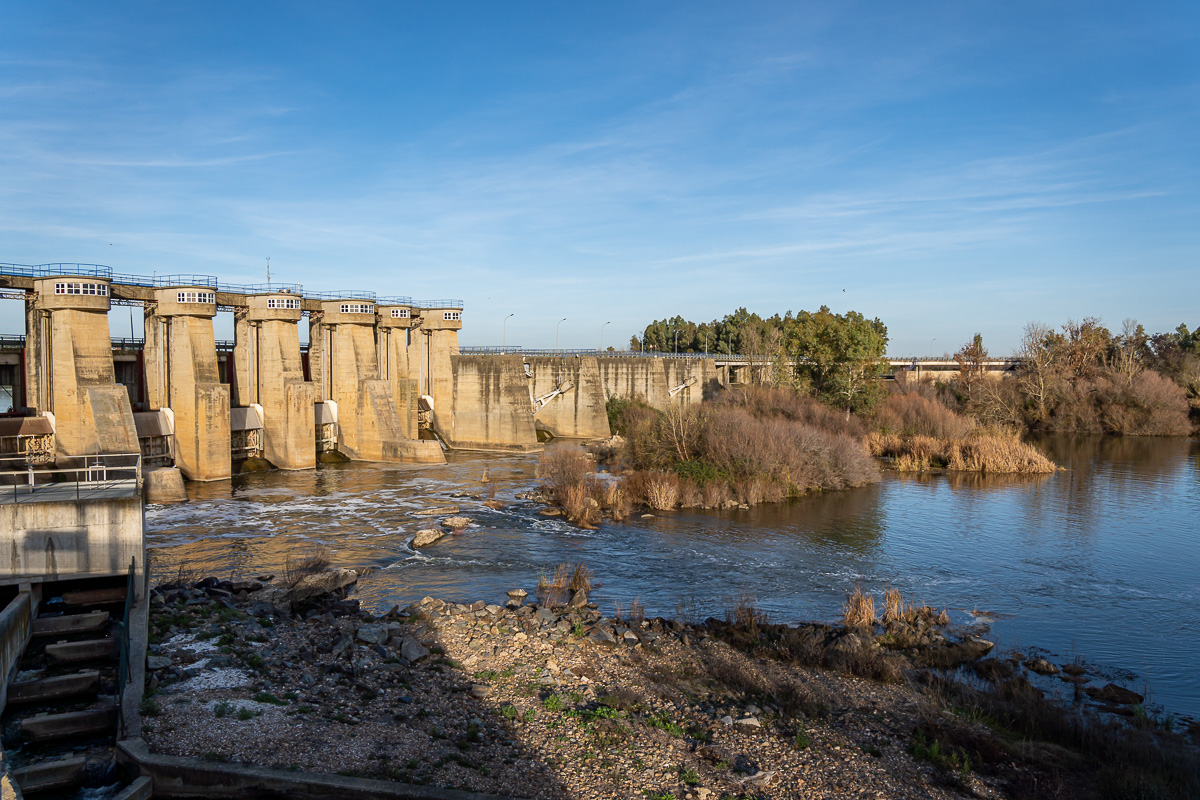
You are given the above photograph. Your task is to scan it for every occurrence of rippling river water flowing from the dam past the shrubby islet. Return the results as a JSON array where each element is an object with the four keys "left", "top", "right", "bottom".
[{"left": 146, "top": 438, "right": 1200, "bottom": 717}]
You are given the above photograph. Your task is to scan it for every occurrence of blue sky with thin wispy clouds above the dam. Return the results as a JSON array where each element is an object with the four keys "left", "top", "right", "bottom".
[{"left": 0, "top": 1, "right": 1200, "bottom": 355}]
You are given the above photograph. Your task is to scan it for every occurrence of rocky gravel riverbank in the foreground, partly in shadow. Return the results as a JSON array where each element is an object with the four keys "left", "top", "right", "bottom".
[{"left": 142, "top": 570, "right": 1195, "bottom": 800}]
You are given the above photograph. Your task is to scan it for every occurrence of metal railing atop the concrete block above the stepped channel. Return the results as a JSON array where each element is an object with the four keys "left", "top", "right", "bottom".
[{"left": 0, "top": 453, "right": 142, "bottom": 503}]
